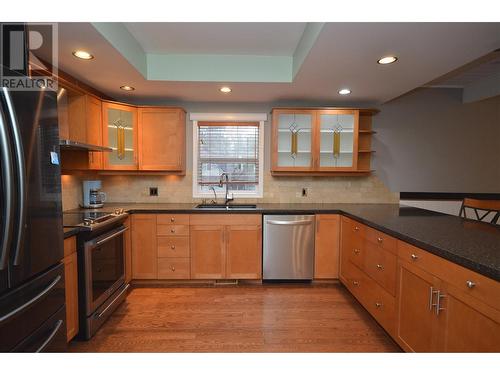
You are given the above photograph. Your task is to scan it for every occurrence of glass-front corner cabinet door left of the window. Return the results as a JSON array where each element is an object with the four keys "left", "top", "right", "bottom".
[{"left": 102, "top": 102, "right": 137, "bottom": 170}]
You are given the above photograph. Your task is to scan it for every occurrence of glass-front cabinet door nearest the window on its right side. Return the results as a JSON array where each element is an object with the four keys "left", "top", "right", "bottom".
[{"left": 272, "top": 109, "right": 315, "bottom": 171}]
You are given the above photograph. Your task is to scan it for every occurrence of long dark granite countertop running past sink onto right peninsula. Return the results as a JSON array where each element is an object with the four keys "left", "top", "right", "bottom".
[{"left": 63, "top": 203, "right": 500, "bottom": 281}]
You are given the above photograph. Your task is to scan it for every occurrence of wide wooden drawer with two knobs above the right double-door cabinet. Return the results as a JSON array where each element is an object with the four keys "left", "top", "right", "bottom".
[{"left": 397, "top": 241, "right": 500, "bottom": 310}]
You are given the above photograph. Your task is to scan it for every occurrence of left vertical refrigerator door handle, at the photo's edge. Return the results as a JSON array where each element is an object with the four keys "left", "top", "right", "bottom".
[{"left": 0, "top": 93, "right": 14, "bottom": 271}]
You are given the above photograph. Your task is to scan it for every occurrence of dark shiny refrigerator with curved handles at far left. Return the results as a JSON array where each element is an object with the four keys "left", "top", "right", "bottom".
[{"left": 0, "top": 25, "right": 66, "bottom": 352}]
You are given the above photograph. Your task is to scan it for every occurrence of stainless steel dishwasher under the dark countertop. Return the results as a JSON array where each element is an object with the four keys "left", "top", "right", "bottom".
[{"left": 263, "top": 215, "right": 314, "bottom": 280}]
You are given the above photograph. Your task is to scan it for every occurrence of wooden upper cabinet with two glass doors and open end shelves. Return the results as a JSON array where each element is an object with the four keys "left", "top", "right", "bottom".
[{"left": 271, "top": 108, "right": 375, "bottom": 176}]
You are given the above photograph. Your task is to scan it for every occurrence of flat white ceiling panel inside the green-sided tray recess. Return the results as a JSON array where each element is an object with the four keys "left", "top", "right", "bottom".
[{"left": 124, "top": 22, "right": 306, "bottom": 56}]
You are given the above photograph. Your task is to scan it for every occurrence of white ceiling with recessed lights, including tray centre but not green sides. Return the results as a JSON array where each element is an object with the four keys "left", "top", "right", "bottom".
[{"left": 53, "top": 23, "right": 500, "bottom": 105}]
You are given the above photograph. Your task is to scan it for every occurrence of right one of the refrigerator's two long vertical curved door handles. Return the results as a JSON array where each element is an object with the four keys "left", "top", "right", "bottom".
[{"left": 2, "top": 87, "right": 27, "bottom": 266}]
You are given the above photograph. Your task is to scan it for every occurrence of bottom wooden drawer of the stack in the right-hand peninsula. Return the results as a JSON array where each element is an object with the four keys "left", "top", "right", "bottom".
[{"left": 343, "top": 263, "right": 396, "bottom": 335}]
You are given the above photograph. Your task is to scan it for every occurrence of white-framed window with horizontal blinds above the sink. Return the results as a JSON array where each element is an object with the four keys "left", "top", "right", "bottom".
[{"left": 193, "top": 113, "right": 264, "bottom": 198}]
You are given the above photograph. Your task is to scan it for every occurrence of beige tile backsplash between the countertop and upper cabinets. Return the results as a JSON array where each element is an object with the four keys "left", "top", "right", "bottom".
[{"left": 62, "top": 173, "right": 399, "bottom": 210}]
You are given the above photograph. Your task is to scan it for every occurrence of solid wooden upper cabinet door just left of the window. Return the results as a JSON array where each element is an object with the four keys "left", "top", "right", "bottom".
[{"left": 138, "top": 107, "right": 186, "bottom": 172}]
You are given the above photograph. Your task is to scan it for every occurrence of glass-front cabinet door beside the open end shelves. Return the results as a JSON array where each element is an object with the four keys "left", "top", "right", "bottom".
[{"left": 317, "top": 110, "right": 358, "bottom": 170}]
